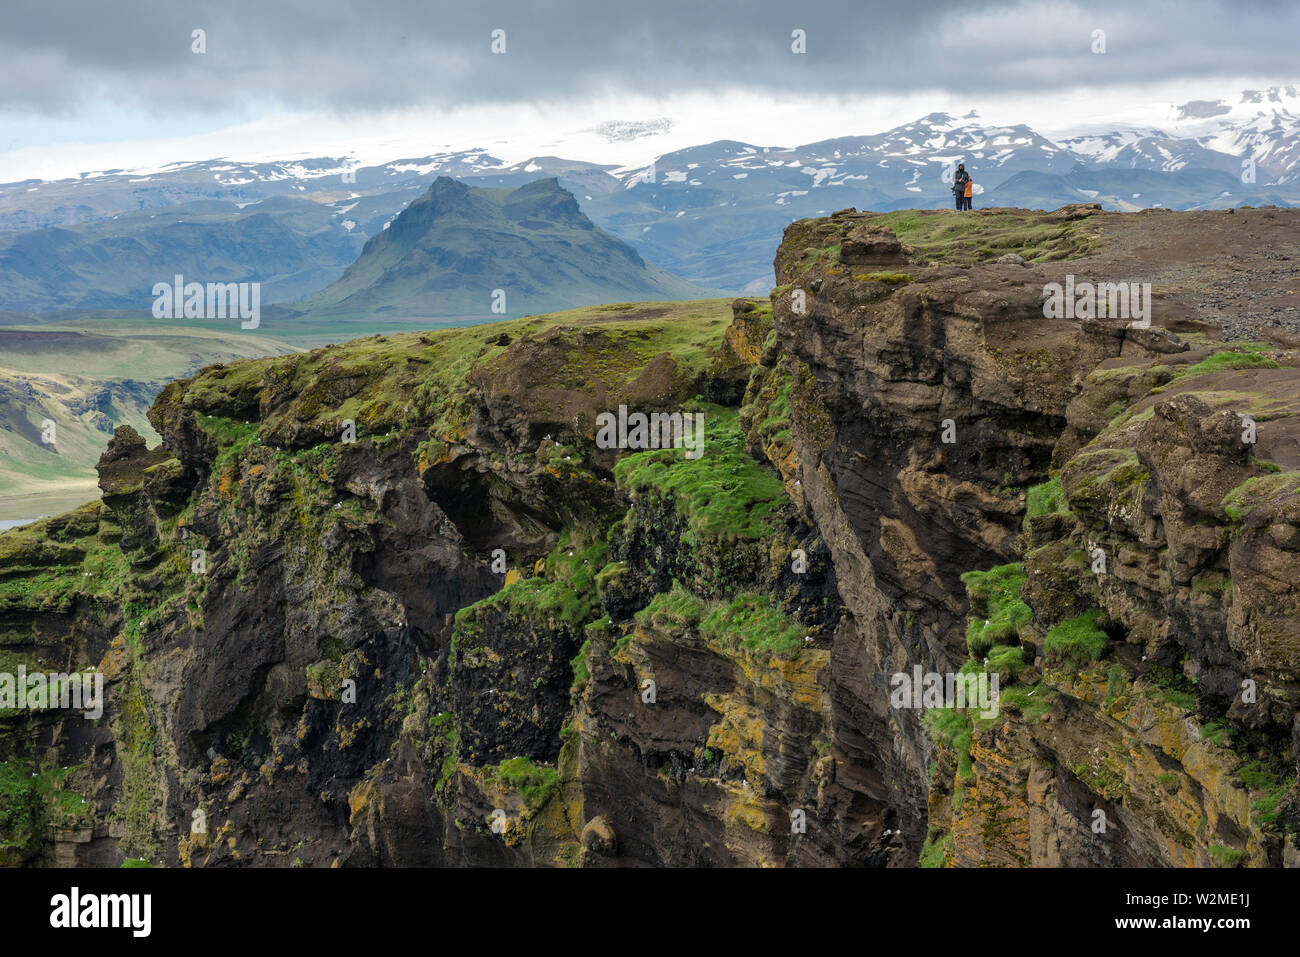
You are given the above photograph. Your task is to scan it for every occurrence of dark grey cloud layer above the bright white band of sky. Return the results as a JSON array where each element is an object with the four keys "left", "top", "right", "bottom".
[{"left": 0, "top": 0, "right": 1300, "bottom": 113}]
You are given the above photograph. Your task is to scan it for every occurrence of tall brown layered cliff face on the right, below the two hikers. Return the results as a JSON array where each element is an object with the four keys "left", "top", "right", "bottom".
[{"left": 772, "top": 208, "right": 1300, "bottom": 866}]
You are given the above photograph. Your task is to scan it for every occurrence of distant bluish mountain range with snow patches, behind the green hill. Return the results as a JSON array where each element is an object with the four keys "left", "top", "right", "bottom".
[{"left": 0, "top": 86, "right": 1300, "bottom": 306}]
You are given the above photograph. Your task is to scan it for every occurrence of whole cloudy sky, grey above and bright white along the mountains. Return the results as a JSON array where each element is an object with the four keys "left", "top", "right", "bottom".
[{"left": 0, "top": 0, "right": 1300, "bottom": 181}]
